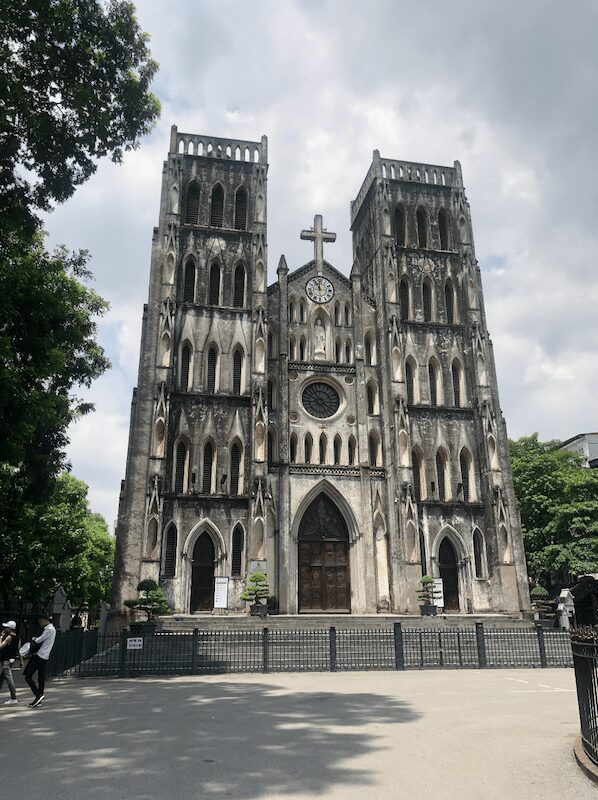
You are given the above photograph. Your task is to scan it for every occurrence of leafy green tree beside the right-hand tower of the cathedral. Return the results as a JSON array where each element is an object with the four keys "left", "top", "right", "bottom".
[{"left": 510, "top": 433, "right": 598, "bottom": 585}]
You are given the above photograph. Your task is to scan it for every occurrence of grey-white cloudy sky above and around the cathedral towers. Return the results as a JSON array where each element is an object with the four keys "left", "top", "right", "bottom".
[{"left": 47, "top": 0, "right": 598, "bottom": 524}]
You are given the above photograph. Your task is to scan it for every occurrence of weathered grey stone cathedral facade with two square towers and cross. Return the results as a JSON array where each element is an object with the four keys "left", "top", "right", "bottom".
[{"left": 114, "top": 127, "right": 529, "bottom": 614}]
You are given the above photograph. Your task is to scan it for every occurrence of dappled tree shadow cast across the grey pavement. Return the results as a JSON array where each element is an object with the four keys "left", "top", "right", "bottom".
[{"left": 0, "top": 675, "right": 418, "bottom": 800}]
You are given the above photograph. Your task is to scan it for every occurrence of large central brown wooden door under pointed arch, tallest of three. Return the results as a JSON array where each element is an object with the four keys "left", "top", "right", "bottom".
[{"left": 299, "top": 493, "right": 351, "bottom": 613}]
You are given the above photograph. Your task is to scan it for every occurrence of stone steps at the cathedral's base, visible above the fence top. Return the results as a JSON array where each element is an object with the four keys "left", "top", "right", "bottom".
[{"left": 159, "top": 614, "right": 533, "bottom": 633}]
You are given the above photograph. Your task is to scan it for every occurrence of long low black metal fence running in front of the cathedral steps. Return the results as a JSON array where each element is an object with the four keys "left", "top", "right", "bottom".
[{"left": 48, "top": 622, "right": 572, "bottom": 677}]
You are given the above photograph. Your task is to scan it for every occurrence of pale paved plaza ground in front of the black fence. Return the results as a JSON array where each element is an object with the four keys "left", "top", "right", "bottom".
[{"left": 0, "top": 669, "right": 598, "bottom": 800}]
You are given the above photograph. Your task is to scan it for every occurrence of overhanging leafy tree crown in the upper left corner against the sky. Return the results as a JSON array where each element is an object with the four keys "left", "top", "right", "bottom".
[{"left": 0, "top": 0, "right": 160, "bottom": 230}]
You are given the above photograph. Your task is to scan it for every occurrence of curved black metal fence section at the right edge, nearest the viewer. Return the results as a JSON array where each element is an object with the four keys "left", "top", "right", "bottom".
[{"left": 571, "top": 628, "right": 598, "bottom": 766}]
